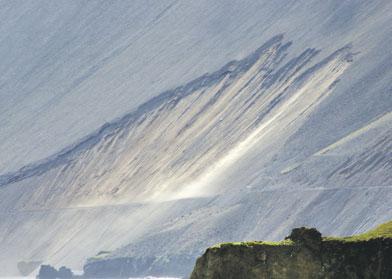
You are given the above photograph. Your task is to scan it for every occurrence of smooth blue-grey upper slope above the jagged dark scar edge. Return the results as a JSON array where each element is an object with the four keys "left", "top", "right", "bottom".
[{"left": 0, "top": 0, "right": 392, "bottom": 174}]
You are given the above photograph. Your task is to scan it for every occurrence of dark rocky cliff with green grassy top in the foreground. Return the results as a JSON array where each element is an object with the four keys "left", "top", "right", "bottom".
[{"left": 191, "top": 222, "right": 392, "bottom": 279}]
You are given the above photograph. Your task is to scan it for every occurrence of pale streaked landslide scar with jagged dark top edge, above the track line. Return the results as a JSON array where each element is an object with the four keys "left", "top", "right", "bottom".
[{"left": 1, "top": 36, "right": 352, "bottom": 210}]
